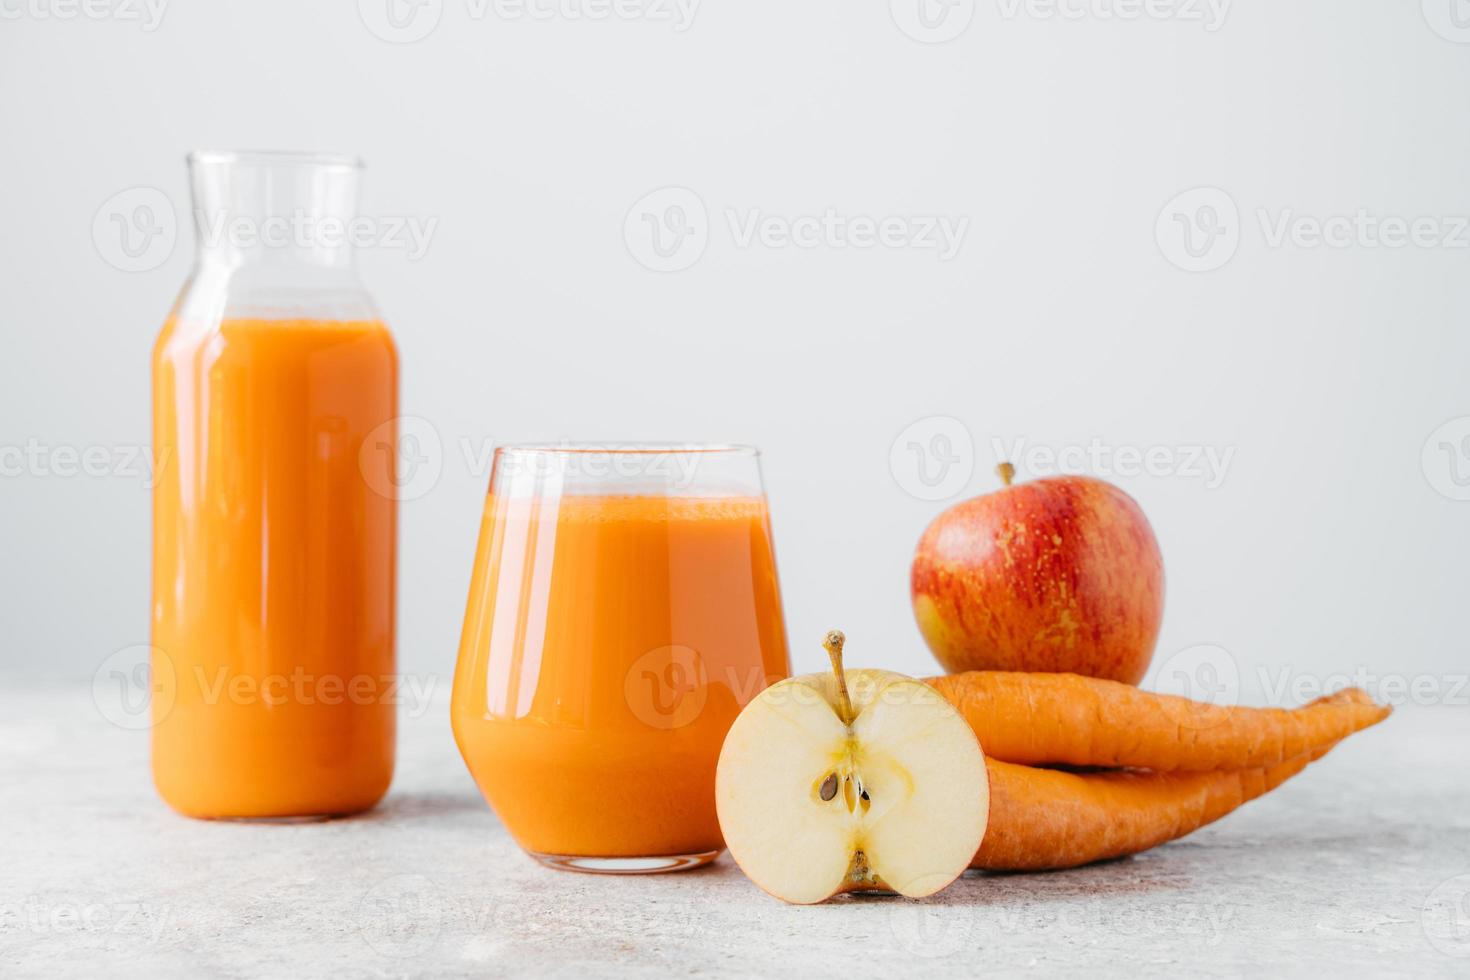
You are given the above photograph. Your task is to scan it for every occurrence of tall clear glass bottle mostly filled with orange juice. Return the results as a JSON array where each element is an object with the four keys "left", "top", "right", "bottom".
[{"left": 151, "top": 153, "right": 398, "bottom": 818}]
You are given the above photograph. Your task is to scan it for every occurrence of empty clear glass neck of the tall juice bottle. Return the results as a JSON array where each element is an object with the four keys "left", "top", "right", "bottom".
[{"left": 190, "top": 153, "right": 362, "bottom": 281}]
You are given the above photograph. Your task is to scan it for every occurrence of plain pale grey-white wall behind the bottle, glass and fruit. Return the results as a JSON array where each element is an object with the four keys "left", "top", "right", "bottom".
[{"left": 0, "top": 0, "right": 1470, "bottom": 701}]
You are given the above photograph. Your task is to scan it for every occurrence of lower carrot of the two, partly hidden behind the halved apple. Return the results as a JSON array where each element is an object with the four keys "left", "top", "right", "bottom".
[{"left": 970, "top": 749, "right": 1326, "bottom": 871}]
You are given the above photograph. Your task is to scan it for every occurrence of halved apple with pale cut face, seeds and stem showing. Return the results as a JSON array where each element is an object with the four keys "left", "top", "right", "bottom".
[{"left": 714, "top": 630, "right": 989, "bottom": 904}]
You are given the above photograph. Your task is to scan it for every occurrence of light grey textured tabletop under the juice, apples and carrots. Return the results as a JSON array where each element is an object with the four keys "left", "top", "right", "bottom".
[{"left": 0, "top": 688, "right": 1470, "bottom": 979}]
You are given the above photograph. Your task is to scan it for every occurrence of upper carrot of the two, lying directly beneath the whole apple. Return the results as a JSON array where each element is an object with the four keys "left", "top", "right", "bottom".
[{"left": 926, "top": 670, "right": 1389, "bottom": 771}]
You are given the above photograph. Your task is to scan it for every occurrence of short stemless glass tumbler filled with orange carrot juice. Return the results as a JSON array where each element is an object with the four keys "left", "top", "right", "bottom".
[{"left": 453, "top": 447, "right": 789, "bottom": 873}]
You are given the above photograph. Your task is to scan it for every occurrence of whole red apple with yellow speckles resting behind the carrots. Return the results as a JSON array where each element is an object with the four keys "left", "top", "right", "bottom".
[{"left": 910, "top": 463, "right": 1164, "bottom": 685}]
